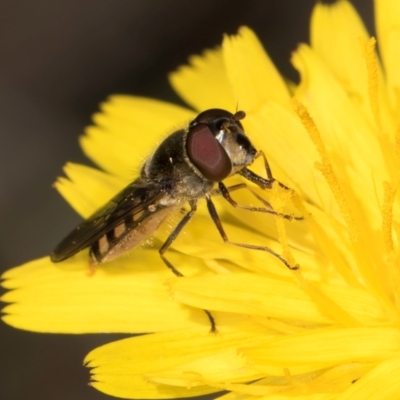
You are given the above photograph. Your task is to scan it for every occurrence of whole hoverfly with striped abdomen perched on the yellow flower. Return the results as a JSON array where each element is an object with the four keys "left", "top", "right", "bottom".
[{"left": 51, "top": 109, "right": 297, "bottom": 331}]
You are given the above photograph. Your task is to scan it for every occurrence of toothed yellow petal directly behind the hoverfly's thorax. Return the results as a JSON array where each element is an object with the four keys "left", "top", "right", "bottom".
[{"left": 81, "top": 96, "right": 194, "bottom": 178}]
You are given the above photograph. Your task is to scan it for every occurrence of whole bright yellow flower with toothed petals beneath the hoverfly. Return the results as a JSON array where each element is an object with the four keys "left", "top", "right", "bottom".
[{"left": 3, "top": 0, "right": 400, "bottom": 400}]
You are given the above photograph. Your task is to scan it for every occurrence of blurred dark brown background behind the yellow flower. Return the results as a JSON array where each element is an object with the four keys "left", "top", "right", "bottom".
[{"left": 0, "top": 0, "right": 373, "bottom": 400}]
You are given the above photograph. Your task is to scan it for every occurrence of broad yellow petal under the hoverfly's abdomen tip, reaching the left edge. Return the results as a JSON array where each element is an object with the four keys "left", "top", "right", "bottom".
[{"left": 2, "top": 249, "right": 228, "bottom": 333}]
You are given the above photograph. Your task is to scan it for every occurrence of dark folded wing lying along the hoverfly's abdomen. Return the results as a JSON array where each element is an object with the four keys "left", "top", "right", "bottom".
[{"left": 50, "top": 180, "right": 165, "bottom": 262}]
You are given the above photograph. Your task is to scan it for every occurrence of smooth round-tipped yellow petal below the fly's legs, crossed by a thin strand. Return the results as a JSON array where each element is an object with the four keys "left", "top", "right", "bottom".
[{"left": 168, "top": 273, "right": 385, "bottom": 325}]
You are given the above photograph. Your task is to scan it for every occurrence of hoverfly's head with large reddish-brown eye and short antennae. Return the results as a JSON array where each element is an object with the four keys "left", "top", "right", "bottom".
[{"left": 186, "top": 108, "right": 257, "bottom": 182}]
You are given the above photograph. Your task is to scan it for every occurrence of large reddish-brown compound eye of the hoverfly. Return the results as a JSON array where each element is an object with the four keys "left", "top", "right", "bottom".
[{"left": 186, "top": 124, "right": 232, "bottom": 182}]
